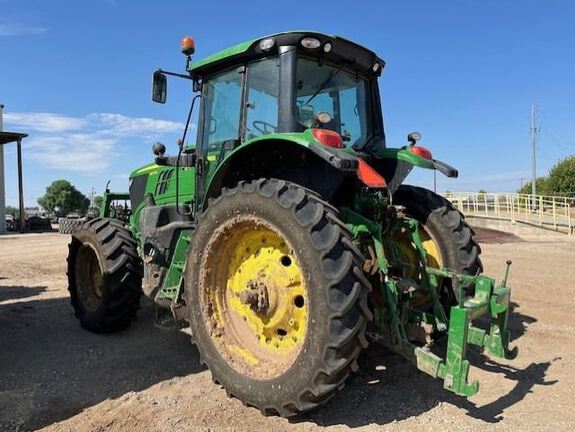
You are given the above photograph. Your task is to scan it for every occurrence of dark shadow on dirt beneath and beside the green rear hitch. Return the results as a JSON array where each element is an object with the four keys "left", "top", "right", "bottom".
[{"left": 291, "top": 304, "right": 560, "bottom": 428}]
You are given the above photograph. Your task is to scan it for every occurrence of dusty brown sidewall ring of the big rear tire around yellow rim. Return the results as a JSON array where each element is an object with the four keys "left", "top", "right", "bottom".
[{"left": 186, "top": 184, "right": 354, "bottom": 409}]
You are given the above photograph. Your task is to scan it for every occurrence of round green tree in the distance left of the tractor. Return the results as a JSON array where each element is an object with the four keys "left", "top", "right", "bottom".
[{"left": 38, "top": 180, "right": 90, "bottom": 216}]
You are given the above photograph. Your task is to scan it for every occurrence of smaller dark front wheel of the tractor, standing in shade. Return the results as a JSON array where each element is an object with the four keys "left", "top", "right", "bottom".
[{"left": 68, "top": 218, "right": 142, "bottom": 333}]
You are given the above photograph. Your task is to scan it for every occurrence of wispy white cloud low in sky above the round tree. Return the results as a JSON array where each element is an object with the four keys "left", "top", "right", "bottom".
[{"left": 4, "top": 112, "right": 184, "bottom": 175}]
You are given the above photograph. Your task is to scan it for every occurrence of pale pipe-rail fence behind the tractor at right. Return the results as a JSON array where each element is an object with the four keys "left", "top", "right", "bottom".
[{"left": 443, "top": 192, "right": 575, "bottom": 235}]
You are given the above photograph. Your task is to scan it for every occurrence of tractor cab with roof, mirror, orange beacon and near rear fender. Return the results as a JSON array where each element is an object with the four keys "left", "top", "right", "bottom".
[{"left": 153, "top": 31, "right": 396, "bottom": 214}]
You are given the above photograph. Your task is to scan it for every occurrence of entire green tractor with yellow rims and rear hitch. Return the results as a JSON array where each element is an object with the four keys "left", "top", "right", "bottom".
[{"left": 68, "top": 32, "right": 517, "bottom": 416}]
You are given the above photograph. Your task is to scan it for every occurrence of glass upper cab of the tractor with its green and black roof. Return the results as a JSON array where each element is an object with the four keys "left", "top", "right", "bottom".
[{"left": 154, "top": 32, "right": 384, "bottom": 158}]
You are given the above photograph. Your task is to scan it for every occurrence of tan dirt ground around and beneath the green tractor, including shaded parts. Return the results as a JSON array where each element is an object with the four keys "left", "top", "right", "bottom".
[{"left": 0, "top": 231, "right": 575, "bottom": 432}]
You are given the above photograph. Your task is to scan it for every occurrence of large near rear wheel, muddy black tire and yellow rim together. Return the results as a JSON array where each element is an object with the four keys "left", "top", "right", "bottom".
[{"left": 185, "top": 179, "right": 371, "bottom": 416}]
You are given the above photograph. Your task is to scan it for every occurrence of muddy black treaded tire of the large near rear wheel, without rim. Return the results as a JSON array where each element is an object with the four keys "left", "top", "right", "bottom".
[{"left": 184, "top": 179, "right": 371, "bottom": 417}]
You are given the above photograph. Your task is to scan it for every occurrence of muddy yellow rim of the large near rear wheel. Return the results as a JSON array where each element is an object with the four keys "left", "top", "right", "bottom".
[{"left": 201, "top": 217, "right": 308, "bottom": 379}]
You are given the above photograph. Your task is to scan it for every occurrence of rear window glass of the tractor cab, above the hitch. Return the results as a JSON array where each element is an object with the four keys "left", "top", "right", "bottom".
[{"left": 295, "top": 58, "right": 371, "bottom": 147}]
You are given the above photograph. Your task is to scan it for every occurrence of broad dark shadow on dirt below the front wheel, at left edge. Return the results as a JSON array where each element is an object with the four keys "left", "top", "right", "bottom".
[{"left": 0, "top": 287, "right": 204, "bottom": 431}]
